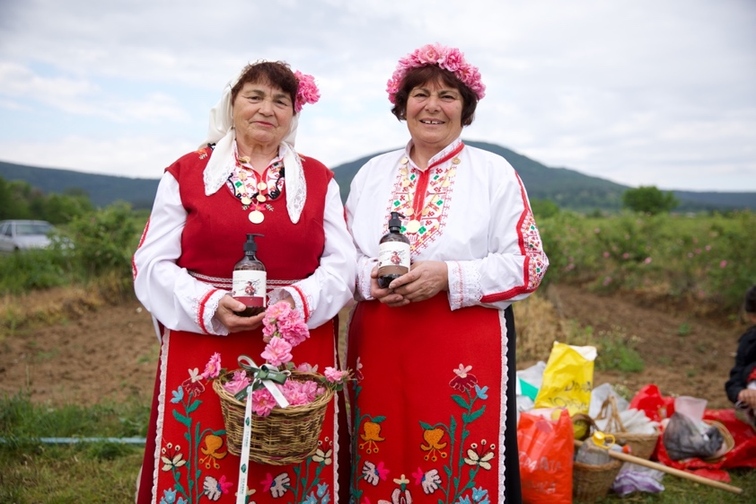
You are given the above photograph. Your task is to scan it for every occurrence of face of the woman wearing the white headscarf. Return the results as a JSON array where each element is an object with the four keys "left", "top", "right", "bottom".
[{"left": 233, "top": 82, "right": 294, "bottom": 155}]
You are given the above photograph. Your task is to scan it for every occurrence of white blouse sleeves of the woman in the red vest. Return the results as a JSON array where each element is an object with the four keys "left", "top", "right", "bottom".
[{"left": 133, "top": 158, "right": 355, "bottom": 338}]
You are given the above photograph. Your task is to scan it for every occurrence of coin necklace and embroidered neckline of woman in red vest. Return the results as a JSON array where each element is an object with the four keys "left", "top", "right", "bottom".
[{"left": 229, "top": 158, "right": 284, "bottom": 224}]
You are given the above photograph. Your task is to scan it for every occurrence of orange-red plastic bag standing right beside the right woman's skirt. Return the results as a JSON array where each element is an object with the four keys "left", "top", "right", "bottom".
[{"left": 517, "top": 409, "right": 575, "bottom": 504}]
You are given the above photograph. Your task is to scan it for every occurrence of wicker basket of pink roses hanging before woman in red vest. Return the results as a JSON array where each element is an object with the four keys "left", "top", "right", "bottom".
[{"left": 213, "top": 371, "right": 334, "bottom": 465}]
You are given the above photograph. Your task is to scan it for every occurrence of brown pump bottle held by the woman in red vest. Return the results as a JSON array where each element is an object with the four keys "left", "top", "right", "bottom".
[{"left": 231, "top": 233, "right": 267, "bottom": 317}]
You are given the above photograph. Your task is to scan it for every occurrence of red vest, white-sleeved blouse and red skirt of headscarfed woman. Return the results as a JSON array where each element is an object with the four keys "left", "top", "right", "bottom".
[{"left": 134, "top": 144, "right": 354, "bottom": 504}]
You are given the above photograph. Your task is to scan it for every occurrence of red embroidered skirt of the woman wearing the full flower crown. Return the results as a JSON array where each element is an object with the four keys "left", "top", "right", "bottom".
[{"left": 348, "top": 293, "right": 510, "bottom": 503}]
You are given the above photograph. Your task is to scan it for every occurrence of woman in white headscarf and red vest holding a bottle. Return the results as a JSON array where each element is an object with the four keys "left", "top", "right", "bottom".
[{"left": 133, "top": 61, "right": 355, "bottom": 504}]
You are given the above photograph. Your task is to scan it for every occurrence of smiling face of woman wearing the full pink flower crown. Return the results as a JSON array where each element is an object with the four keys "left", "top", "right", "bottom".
[{"left": 406, "top": 81, "right": 464, "bottom": 154}]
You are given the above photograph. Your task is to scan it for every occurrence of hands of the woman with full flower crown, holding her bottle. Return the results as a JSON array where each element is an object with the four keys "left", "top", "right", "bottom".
[{"left": 370, "top": 261, "right": 449, "bottom": 306}]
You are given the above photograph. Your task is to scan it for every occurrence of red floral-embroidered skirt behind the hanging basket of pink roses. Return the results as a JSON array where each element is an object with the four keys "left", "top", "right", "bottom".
[{"left": 137, "top": 322, "right": 339, "bottom": 504}]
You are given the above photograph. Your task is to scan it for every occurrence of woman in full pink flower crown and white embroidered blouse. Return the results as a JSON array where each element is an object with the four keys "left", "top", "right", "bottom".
[{"left": 346, "top": 44, "right": 548, "bottom": 503}]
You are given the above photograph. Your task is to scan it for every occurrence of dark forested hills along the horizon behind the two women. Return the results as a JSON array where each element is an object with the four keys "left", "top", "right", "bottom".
[{"left": 0, "top": 141, "right": 756, "bottom": 212}]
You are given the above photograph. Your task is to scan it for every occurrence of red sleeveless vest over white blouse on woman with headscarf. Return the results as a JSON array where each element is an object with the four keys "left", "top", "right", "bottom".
[{"left": 166, "top": 148, "right": 333, "bottom": 280}]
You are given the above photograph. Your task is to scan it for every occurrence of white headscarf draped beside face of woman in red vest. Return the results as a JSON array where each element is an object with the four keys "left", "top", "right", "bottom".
[{"left": 200, "top": 68, "right": 307, "bottom": 224}]
